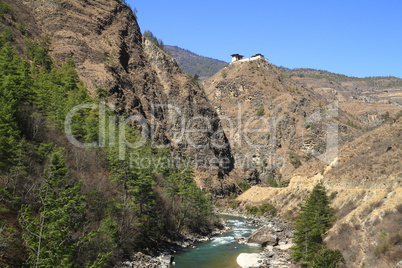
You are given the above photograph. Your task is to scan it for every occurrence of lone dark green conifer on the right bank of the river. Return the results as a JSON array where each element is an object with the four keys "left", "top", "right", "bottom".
[{"left": 292, "top": 183, "right": 333, "bottom": 264}]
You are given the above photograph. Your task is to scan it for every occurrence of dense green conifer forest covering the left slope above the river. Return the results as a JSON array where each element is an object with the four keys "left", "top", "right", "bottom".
[{"left": 0, "top": 4, "right": 216, "bottom": 267}]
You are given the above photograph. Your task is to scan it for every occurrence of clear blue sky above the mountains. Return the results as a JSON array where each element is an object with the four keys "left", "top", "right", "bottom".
[{"left": 127, "top": 0, "right": 402, "bottom": 77}]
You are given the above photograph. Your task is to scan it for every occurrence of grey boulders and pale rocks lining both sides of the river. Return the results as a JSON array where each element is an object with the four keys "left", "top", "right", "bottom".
[{"left": 115, "top": 208, "right": 297, "bottom": 268}]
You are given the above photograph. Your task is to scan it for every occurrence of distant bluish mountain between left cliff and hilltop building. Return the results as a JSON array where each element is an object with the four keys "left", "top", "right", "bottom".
[{"left": 164, "top": 45, "right": 229, "bottom": 80}]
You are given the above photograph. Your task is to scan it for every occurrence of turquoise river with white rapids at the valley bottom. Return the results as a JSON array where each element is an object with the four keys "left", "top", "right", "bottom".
[{"left": 173, "top": 215, "right": 262, "bottom": 268}]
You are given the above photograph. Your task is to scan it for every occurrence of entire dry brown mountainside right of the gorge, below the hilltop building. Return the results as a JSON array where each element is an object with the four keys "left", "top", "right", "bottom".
[{"left": 204, "top": 60, "right": 402, "bottom": 267}]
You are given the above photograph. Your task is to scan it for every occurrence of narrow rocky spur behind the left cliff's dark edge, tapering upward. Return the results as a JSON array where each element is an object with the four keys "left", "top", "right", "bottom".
[{"left": 143, "top": 38, "right": 234, "bottom": 178}]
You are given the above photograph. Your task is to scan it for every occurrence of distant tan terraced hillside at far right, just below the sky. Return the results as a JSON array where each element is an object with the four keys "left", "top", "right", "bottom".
[{"left": 279, "top": 67, "right": 402, "bottom": 128}]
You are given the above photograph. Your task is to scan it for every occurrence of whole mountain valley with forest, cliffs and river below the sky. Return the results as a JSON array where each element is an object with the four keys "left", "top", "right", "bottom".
[{"left": 0, "top": 0, "right": 402, "bottom": 268}]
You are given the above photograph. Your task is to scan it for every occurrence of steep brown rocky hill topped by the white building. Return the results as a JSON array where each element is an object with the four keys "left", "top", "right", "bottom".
[{"left": 203, "top": 59, "right": 360, "bottom": 188}]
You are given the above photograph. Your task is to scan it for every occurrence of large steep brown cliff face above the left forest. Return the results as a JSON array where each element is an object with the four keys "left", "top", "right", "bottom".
[{"left": 23, "top": 0, "right": 233, "bottom": 178}]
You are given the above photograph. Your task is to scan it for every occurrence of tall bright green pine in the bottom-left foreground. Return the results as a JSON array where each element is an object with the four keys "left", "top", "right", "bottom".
[{"left": 20, "top": 149, "right": 85, "bottom": 267}]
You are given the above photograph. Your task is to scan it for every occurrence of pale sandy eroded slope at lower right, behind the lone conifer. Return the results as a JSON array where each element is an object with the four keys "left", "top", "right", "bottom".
[{"left": 238, "top": 118, "right": 402, "bottom": 267}]
